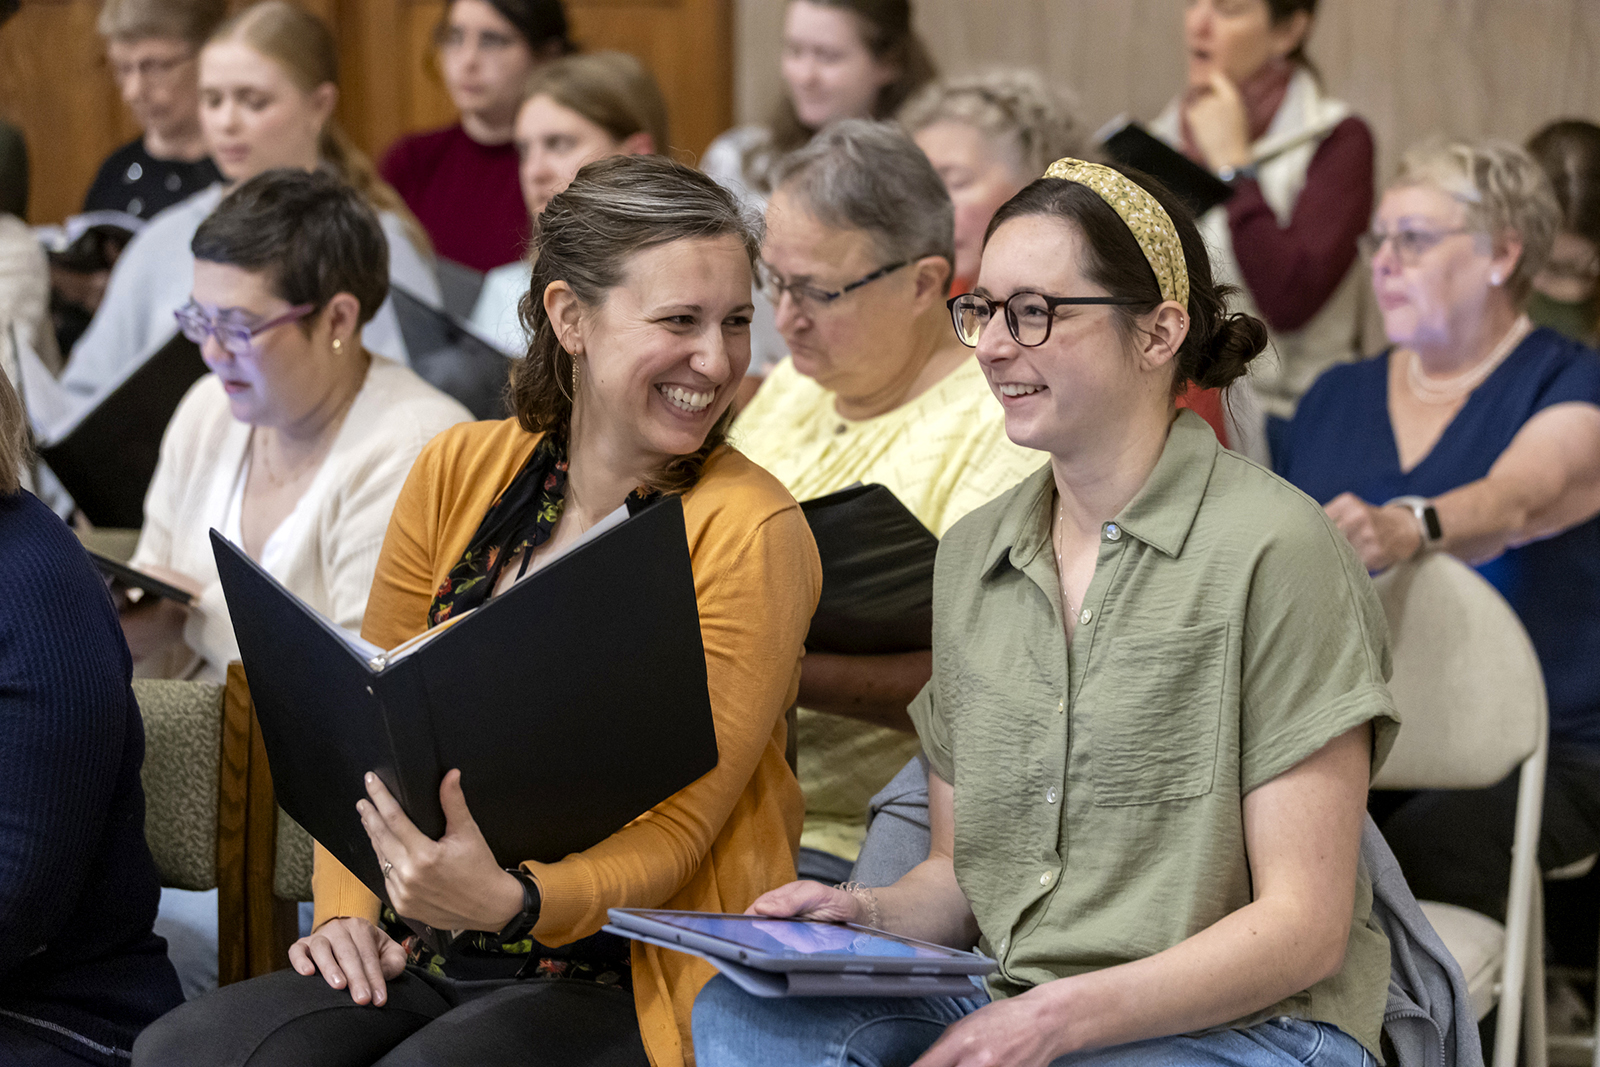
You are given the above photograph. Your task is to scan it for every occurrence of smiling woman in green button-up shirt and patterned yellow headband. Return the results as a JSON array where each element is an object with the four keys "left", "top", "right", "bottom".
[{"left": 694, "top": 160, "right": 1395, "bottom": 1067}]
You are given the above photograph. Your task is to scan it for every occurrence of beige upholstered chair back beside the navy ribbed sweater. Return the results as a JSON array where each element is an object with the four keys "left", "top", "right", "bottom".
[{"left": 133, "top": 678, "right": 224, "bottom": 889}]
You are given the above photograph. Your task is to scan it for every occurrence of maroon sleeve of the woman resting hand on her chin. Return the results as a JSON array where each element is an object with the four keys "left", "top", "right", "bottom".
[{"left": 1227, "top": 115, "right": 1373, "bottom": 333}]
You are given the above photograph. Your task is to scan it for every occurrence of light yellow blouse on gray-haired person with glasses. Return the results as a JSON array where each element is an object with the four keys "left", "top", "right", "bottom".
[{"left": 731, "top": 351, "right": 1046, "bottom": 859}]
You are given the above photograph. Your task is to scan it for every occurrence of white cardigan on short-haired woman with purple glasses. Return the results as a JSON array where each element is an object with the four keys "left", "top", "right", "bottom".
[{"left": 133, "top": 357, "right": 472, "bottom": 681}]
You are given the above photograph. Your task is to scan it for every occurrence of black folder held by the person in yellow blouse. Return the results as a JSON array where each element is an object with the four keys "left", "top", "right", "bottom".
[{"left": 800, "top": 485, "right": 939, "bottom": 656}]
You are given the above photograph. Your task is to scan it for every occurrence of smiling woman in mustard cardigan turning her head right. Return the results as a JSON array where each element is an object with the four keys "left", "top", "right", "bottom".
[{"left": 134, "top": 157, "right": 822, "bottom": 1067}]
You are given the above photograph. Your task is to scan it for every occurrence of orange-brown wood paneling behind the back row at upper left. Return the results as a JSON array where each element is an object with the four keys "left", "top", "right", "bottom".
[{"left": 0, "top": 0, "right": 733, "bottom": 222}]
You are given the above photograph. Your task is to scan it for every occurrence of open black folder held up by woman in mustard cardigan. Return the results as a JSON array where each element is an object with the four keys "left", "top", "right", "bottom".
[{"left": 211, "top": 496, "right": 717, "bottom": 921}]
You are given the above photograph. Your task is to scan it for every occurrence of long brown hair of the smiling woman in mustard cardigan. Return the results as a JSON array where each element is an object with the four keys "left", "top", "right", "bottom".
[{"left": 510, "top": 155, "right": 760, "bottom": 493}]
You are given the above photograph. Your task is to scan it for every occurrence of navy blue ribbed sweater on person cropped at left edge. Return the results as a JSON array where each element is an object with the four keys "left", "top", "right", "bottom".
[{"left": 0, "top": 493, "right": 182, "bottom": 1064}]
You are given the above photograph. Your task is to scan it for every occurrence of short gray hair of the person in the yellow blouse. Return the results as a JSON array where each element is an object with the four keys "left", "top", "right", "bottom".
[{"left": 773, "top": 118, "right": 955, "bottom": 270}]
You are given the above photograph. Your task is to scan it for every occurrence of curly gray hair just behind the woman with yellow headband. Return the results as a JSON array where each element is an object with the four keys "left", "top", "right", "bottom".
[{"left": 901, "top": 69, "right": 1086, "bottom": 184}]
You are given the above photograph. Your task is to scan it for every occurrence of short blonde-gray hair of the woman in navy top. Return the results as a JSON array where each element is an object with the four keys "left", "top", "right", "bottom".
[{"left": 1387, "top": 139, "right": 1562, "bottom": 304}]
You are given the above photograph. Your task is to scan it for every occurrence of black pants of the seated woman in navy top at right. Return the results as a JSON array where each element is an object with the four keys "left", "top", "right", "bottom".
[{"left": 1371, "top": 745, "right": 1600, "bottom": 921}]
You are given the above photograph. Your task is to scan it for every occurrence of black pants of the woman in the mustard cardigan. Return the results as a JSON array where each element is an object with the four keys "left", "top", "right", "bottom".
[{"left": 133, "top": 968, "right": 650, "bottom": 1067}]
